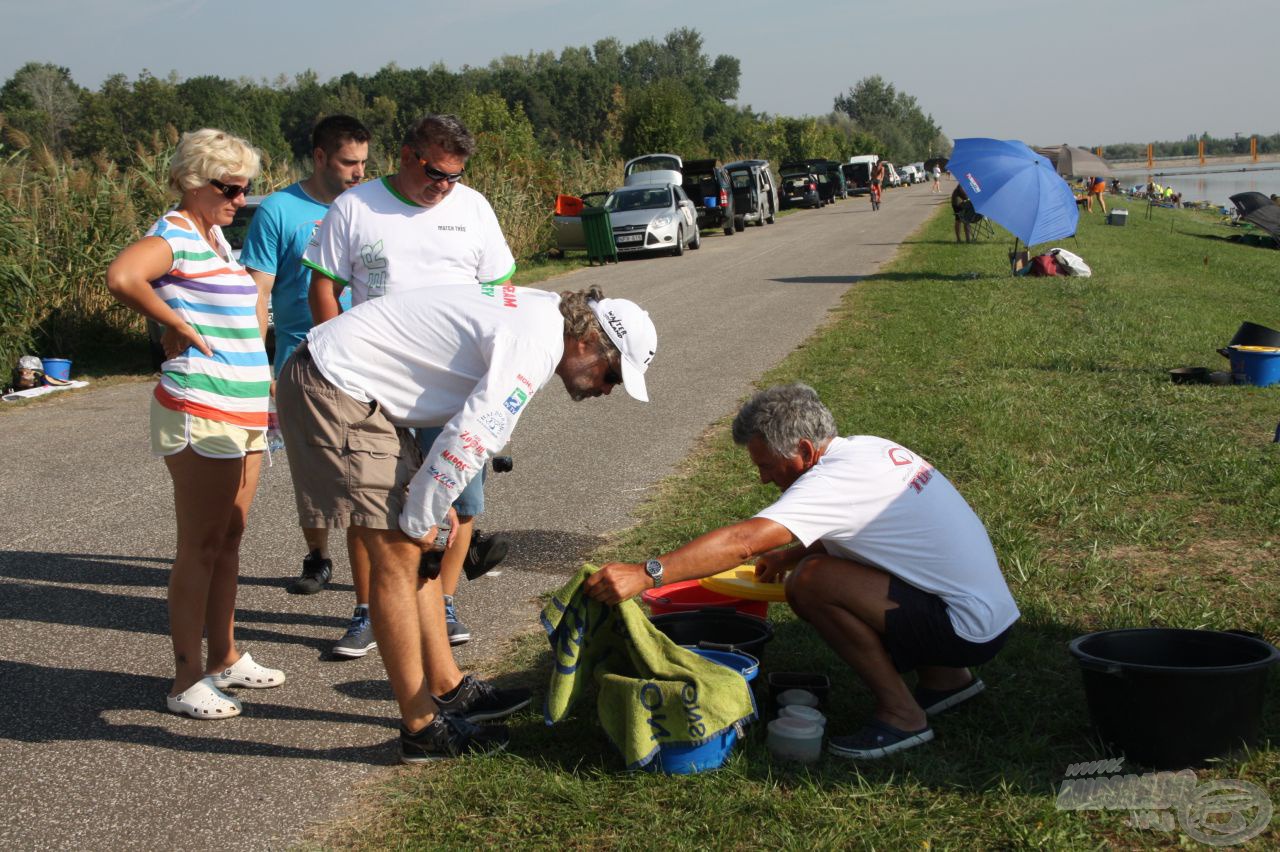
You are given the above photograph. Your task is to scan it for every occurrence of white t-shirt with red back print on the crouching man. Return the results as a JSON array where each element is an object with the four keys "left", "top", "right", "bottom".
[{"left": 756, "top": 435, "right": 1019, "bottom": 642}]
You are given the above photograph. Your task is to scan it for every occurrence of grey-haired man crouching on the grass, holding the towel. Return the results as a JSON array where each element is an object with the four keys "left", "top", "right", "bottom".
[{"left": 586, "top": 384, "right": 1019, "bottom": 759}]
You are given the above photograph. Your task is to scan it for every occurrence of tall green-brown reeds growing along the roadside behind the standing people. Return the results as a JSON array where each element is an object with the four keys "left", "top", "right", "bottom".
[{"left": 0, "top": 115, "right": 622, "bottom": 375}]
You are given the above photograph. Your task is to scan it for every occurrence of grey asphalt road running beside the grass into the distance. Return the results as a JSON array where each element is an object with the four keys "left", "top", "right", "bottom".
[{"left": 0, "top": 184, "right": 946, "bottom": 849}]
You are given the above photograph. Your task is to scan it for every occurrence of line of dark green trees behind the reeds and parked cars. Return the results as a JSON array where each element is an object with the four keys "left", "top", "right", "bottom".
[{"left": 0, "top": 28, "right": 950, "bottom": 165}]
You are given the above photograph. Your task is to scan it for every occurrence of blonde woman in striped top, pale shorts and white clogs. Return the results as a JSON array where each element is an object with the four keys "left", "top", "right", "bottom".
[{"left": 106, "top": 129, "right": 284, "bottom": 719}]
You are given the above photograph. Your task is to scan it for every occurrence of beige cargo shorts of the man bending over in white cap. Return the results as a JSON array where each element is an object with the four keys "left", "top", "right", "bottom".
[{"left": 275, "top": 343, "right": 422, "bottom": 530}]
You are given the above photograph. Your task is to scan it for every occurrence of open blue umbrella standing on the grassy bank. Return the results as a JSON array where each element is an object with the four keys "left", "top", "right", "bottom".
[{"left": 947, "top": 138, "right": 1080, "bottom": 246}]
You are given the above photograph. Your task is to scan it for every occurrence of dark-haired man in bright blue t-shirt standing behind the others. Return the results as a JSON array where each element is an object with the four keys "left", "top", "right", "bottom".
[{"left": 241, "top": 115, "right": 376, "bottom": 658}]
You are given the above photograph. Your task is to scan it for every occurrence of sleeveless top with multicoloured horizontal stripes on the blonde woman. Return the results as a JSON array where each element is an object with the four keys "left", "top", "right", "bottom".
[{"left": 146, "top": 211, "right": 271, "bottom": 430}]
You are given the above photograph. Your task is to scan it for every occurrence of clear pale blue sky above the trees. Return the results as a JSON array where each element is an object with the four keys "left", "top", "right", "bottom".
[{"left": 0, "top": 0, "right": 1280, "bottom": 145}]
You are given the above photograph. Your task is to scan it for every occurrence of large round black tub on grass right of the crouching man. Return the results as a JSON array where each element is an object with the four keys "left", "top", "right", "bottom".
[{"left": 1069, "top": 628, "right": 1280, "bottom": 769}]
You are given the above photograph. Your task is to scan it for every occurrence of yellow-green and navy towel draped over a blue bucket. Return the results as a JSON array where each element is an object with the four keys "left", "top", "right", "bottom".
[{"left": 541, "top": 565, "right": 755, "bottom": 769}]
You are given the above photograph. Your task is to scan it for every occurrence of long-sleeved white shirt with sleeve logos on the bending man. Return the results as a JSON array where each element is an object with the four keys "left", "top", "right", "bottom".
[{"left": 307, "top": 285, "right": 564, "bottom": 539}]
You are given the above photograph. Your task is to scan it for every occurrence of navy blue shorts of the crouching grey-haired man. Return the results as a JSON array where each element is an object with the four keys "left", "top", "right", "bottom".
[{"left": 881, "top": 576, "right": 1014, "bottom": 673}]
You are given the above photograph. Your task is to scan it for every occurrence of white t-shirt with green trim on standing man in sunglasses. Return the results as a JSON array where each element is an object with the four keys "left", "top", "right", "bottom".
[{"left": 302, "top": 178, "right": 516, "bottom": 304}]
